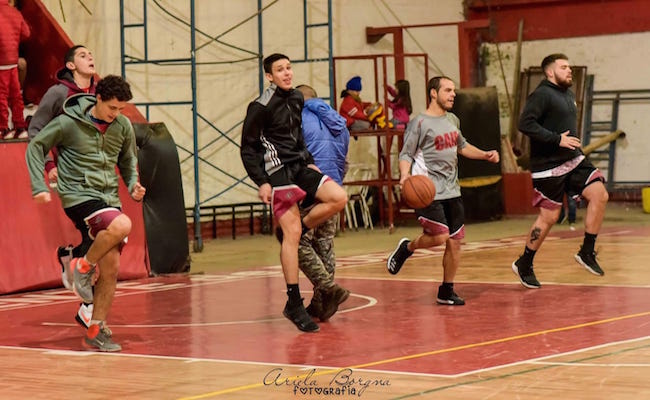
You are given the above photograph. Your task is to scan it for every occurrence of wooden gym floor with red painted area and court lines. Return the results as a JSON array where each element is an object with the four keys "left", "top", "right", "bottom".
[{"left": 0, "top": 204, "right": 650, "bottom": 400}]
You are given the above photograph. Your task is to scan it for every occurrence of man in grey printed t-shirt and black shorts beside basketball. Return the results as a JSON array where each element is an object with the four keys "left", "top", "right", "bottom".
[{"left": 386, "top": 76, "right": 499, "bottom": 305}]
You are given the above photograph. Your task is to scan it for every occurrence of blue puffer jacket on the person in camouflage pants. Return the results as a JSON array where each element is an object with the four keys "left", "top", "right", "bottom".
[{"left": 302, "top": 98, "right": 350, "bottom": 185}]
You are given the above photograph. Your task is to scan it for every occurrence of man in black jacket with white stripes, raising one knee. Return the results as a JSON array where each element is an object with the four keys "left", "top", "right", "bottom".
[{"left": 240, "top": 53, "right": 347, "bottom": 332}]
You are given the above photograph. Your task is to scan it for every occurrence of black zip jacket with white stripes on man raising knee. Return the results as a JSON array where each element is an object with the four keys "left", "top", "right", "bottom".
[{"left": 240, "top": 84, "right": 314, "bottom": 186}]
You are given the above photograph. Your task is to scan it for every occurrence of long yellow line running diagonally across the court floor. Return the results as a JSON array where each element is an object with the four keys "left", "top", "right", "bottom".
[{"left": 179, "top": 311, "right": 650, "bottom": 400}]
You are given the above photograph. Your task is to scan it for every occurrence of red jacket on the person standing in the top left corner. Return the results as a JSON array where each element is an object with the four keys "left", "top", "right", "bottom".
[{"left": 0, "top": 0, "right": 30, "bottom": 65}]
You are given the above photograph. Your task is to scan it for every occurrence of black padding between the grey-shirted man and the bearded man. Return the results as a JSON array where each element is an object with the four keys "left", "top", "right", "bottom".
[{"left": 452, "top": 87, "right": 503, "bottom": 221}]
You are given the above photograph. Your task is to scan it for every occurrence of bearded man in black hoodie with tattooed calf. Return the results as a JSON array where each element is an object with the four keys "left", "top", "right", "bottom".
[{"left": 512, "top": 54, "right": 608, "bottom": 289}]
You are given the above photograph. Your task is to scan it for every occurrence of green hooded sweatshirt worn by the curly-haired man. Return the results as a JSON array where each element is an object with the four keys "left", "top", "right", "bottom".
[{"left": 25, "top": 94, "right": 138, "bottom": 208}]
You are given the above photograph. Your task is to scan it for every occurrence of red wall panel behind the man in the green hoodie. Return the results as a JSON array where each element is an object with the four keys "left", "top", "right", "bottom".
[{"left": 0, "top": 142, "right": 149, "bottom": 294}]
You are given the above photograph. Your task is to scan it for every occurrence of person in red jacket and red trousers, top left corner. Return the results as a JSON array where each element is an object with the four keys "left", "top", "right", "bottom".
[{"left": 0, "top": 1, "right": 30, "bottom": 139}]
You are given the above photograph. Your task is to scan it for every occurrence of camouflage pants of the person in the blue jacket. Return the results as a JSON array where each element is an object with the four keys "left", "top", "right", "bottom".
[{"left": 298, "top": 214, "right": 339, "bottom": 289}]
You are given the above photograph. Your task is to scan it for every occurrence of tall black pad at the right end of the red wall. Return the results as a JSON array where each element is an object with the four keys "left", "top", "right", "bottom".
[{"left": 133, "top": 123, "right": 190, "bottom": 275}]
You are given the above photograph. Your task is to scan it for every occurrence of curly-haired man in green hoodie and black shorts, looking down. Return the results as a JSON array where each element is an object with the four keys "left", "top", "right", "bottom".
[{"left": 25, "top": 75, "right": 145, "bottom": 351}]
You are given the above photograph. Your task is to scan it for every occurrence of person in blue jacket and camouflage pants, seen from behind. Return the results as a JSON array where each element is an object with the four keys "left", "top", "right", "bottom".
[{"left": 296, "top": 85, "right": 350, "bottom": 321}]
